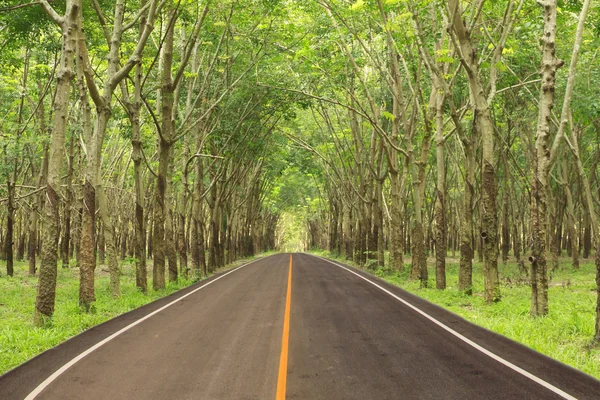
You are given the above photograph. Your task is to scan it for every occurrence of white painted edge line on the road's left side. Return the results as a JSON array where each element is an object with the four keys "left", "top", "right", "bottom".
[{"left": 25, "top": 258, "right": 264, "bottom": 400}]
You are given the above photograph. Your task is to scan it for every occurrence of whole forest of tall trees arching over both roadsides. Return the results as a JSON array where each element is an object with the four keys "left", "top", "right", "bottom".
[{"left": 0, "top": 0, "right": 600, "bottom": 382}]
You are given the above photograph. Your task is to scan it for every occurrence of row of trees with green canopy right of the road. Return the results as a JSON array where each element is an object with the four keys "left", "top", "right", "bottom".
[{"left": 278, "top": 0, "right": 600, "bottom": 341}]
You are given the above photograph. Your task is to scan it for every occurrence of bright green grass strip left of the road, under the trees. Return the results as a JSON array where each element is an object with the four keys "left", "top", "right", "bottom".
[{"left": 0, "top": 253, "right": 270, "bottom": 375}]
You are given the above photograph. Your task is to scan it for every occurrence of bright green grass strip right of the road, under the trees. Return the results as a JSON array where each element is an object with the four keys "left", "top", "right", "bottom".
[{"left": 310, "top": 252, "right": 600, "bottom": 379}]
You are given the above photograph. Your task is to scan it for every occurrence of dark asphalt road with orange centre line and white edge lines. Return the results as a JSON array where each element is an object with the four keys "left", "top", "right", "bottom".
[{"left": 0, "top": 254, "right": 600, "bottom": 400}]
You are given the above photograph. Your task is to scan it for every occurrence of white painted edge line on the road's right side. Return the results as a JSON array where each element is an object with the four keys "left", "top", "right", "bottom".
[{"left": 310, "top": 254, "right": 577, "bottom": 400}]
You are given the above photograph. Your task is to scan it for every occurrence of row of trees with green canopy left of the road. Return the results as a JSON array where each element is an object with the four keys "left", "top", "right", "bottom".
[{"left": 0, "top": 0, "right": 292, "bottom": 325}]
